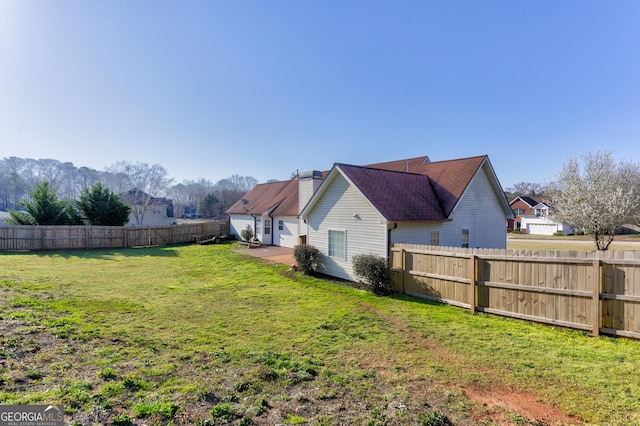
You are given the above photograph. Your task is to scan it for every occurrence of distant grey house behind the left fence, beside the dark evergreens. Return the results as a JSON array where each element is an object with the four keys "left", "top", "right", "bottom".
[{"left": 119, "top": 188, "right": 174, "bottom": 226}]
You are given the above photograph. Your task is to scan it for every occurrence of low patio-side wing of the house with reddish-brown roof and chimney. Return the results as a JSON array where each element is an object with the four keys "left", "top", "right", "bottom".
[{"left": 226, "top": 171, "right": 322, "bottom": 247}]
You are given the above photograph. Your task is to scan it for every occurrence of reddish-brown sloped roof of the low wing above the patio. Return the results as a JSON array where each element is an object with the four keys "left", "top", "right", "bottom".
[{"left": 226, "top": 178, "right": 298, "bottom": 216}]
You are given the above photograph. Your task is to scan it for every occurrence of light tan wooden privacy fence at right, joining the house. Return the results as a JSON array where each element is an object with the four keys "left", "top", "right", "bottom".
[{"left": 390, "top": 244, "right": 640, "bottom": 338}]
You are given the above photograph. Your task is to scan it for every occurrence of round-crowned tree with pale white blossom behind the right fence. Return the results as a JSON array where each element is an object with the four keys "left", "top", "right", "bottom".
[{"left": 552, "top": 151, "right": 640, "bottom": 250}]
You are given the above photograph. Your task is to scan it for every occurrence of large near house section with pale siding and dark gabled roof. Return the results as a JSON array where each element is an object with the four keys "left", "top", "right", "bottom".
[{"left": 300, "top": 156, "right": 512, "bottom": 280}]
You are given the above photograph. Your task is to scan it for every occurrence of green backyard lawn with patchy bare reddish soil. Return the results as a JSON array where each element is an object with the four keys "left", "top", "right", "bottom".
[{"left": 0, "top": 241, "right": 640, "bottom": 426}]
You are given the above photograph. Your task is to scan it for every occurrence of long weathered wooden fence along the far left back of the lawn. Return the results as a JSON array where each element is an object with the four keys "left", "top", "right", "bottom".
[{"left": 0, "top": 220, "right": 229, "bottom": 251}]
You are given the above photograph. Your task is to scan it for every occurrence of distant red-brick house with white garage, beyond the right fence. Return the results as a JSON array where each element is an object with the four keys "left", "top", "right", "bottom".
[{"left": 507, "top": 197, "right": 574, "bottom": 235}]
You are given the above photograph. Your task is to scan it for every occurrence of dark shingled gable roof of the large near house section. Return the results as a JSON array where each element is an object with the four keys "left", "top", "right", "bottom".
[{"left": 302, "top": 155, "right": 511, "bottom": 222}]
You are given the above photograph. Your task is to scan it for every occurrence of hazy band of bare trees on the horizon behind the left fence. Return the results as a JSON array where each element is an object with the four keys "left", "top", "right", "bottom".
[{"left": 0, "top": 157, "right": 258, "bottom": 218}]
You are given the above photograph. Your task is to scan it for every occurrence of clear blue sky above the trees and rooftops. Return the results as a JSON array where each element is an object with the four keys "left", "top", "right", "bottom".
[{"left": 0, "top": 0, "right": 640, "bottom": 189}]
